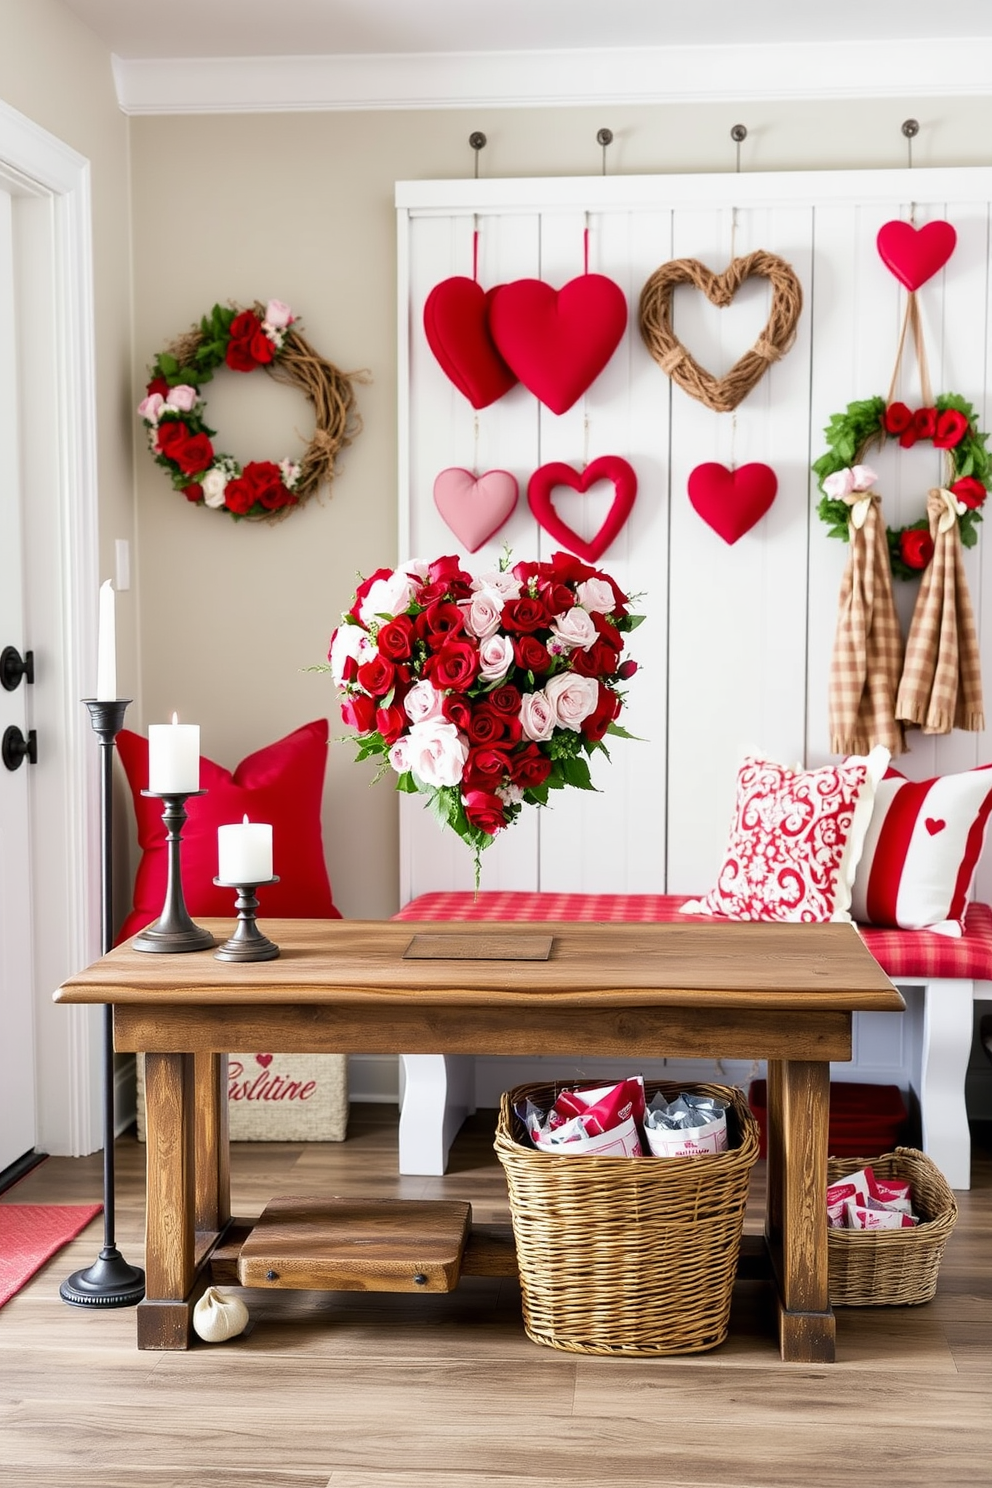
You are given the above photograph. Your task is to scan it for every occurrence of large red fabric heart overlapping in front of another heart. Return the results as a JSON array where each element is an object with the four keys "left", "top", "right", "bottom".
[{"left": 489, "top": 274, "right": 628, "bottom": 414}]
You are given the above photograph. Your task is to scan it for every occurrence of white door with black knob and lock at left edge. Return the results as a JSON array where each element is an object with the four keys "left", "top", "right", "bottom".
[{"left": 0, "top": 180, "right": 37, "bottom": 1171}]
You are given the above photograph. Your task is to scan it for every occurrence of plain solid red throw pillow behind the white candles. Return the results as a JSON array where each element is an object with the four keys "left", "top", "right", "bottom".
[{"left": 117, "top": 719, "right": 341, "bottom": 943}]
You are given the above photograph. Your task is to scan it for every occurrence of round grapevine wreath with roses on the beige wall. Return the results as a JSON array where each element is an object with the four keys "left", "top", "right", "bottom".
[{"left": 138, "top": 299, "right": 360, "bottom": 521}]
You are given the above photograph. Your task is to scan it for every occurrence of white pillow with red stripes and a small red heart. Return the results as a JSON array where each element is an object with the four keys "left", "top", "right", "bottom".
[{"left": 851, "top": 765, "right": 992, "bottom": 936}]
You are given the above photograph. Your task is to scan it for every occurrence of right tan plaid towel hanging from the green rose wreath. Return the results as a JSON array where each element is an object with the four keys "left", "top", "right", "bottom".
[{"left": 895, "top": 488, "right": 985, "bottom": 734}]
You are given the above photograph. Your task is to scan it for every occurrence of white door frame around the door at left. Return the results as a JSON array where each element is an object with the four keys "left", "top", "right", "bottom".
[{"left": 0, "top": 103, "right": 103, "bottom": 1156}]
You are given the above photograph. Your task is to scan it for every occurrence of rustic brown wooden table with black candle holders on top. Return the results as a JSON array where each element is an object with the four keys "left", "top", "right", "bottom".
[{"left": 55, "top": 920, "right": 904, "bottom": 1363}]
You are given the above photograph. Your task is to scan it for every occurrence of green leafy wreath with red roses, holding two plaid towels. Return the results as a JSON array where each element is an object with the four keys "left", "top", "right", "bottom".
[{"left": 814, "top": 393, "right": 992, "bottom": 579}]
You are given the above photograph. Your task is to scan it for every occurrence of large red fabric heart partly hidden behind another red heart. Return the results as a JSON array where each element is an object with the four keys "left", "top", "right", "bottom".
[{"left": 424, "top": 275, "right": 516, "bottom": 408}]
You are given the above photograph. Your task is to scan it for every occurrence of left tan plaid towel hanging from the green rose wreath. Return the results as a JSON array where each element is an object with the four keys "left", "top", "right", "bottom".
[{"left": 830, "top": 491, "right": 904, "bottom": 754}]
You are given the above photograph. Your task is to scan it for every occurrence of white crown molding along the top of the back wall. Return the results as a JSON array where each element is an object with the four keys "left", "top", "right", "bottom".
[{"left": 113, "top": 37, "right": 992, "bottom": 115}]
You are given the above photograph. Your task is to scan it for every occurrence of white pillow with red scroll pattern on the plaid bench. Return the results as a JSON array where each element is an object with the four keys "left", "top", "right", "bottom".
[{"left": 683, "top": 748, "right": 889, "bottom": 923}]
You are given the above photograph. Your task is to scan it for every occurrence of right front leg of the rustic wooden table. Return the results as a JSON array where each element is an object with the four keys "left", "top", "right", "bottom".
[{"left": 766, "top": 1059, "right": 836, "bottom": 1363}]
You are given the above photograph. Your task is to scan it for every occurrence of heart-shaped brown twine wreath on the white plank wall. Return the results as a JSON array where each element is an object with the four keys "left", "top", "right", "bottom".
[{"left": 640, "top": 248, "right": 803, "bottom": 414}]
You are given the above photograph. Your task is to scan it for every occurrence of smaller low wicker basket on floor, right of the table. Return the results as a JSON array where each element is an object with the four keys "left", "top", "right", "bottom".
[{"left": 827, "top": 1147, "right": 958, "bottom": 1306}]
